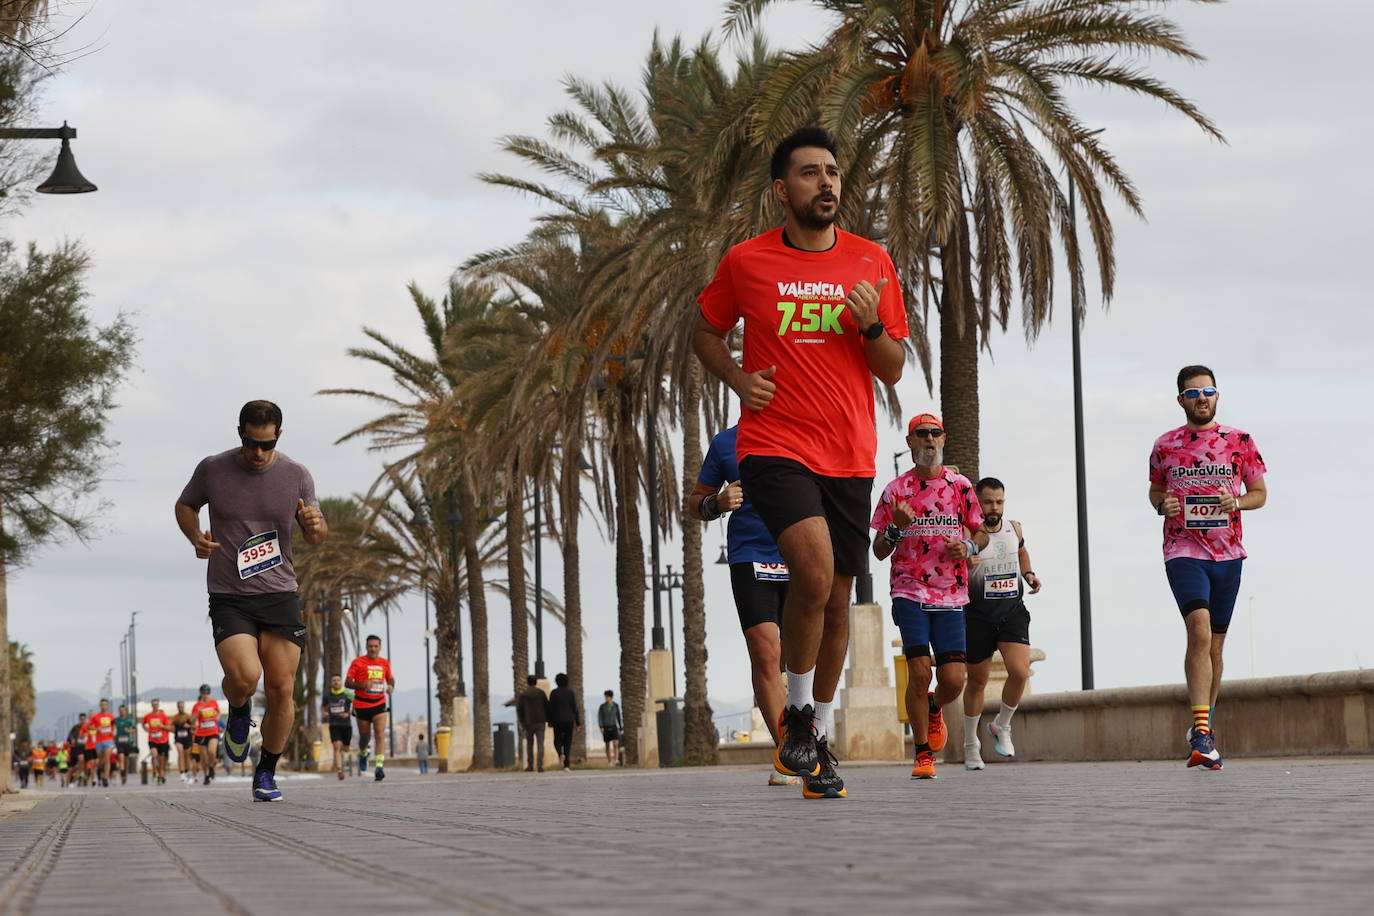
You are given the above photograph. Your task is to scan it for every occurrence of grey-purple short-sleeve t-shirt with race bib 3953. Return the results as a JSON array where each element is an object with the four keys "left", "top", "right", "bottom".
[{"left": 177, "top": 449, "right": 319, "bottom": 595}]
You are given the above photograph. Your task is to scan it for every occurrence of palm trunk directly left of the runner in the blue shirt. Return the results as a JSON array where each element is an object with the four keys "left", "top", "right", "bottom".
[{"left": 679, "top": 356, "right": 716, "bottom": 764}]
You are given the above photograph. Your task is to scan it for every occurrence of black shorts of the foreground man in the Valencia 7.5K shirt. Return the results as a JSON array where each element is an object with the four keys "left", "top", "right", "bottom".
[{"left": 739, "top": 455, "right": 872, "bottom": 575}]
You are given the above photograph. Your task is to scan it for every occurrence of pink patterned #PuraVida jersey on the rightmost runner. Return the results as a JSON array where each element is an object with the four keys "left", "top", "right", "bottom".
[{"left": 1150, "top": 423, "right": 1265, "bottom": 562}]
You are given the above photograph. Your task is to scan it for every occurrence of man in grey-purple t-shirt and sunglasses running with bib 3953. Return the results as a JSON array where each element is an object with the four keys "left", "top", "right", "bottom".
[{"left": 176, "top": 401, "right": 328, "bottom": 802}]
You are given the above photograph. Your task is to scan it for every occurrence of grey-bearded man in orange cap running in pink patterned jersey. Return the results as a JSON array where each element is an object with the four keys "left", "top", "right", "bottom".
[{"left": 870, "top": 413, "right": 988, "bottom": 779}]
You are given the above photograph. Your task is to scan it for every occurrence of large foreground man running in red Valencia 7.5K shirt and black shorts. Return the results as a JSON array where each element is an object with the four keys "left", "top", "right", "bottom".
[{"left": 692, "top": 128, "right": 907, "bottom": 798}]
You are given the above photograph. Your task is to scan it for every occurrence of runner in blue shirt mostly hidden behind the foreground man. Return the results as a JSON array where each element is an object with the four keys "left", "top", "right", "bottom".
[{"left": 687, "top": 426, "right": 796, "bottom": 786}]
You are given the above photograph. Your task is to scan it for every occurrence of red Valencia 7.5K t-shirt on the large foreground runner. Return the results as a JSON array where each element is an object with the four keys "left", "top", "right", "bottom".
[{"left": 697, "top": 228, "right": 908, "bottom": 478}]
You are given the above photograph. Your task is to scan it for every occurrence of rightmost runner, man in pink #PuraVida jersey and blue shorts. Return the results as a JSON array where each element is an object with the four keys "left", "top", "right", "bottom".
[{"left": 1150, "top": 365, "right": 1267, "bottom": 770}]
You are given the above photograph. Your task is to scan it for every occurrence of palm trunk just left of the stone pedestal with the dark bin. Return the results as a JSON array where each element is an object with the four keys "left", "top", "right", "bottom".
[{"left": 611, "top": 389, "right": 647, "bottom": 766}]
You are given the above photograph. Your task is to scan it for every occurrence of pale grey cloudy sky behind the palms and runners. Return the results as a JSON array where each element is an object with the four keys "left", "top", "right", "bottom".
[{"left": 3, "top": 0, "right": 1374, "bottom": 725}]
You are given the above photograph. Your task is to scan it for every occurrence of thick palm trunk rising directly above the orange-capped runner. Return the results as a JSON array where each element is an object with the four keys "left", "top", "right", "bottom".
[{"left": 940, "top": 234, "right": 978, "bottom": 481}]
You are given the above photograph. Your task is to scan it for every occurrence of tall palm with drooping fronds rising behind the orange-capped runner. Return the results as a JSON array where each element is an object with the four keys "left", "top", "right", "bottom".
[{"left": 727, "top": 0, "right": 1221, "bottom": 477}]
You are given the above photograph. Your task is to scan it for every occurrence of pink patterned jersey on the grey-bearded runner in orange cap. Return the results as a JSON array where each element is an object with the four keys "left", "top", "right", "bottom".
[{"left": 870, "top": 468, "right": 982, "bottom": 607}]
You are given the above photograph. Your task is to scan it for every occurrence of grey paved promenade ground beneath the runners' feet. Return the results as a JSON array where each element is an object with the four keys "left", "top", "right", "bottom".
[{"left": 0, "top": 758, "right": 1374, "bottom": 916}]
